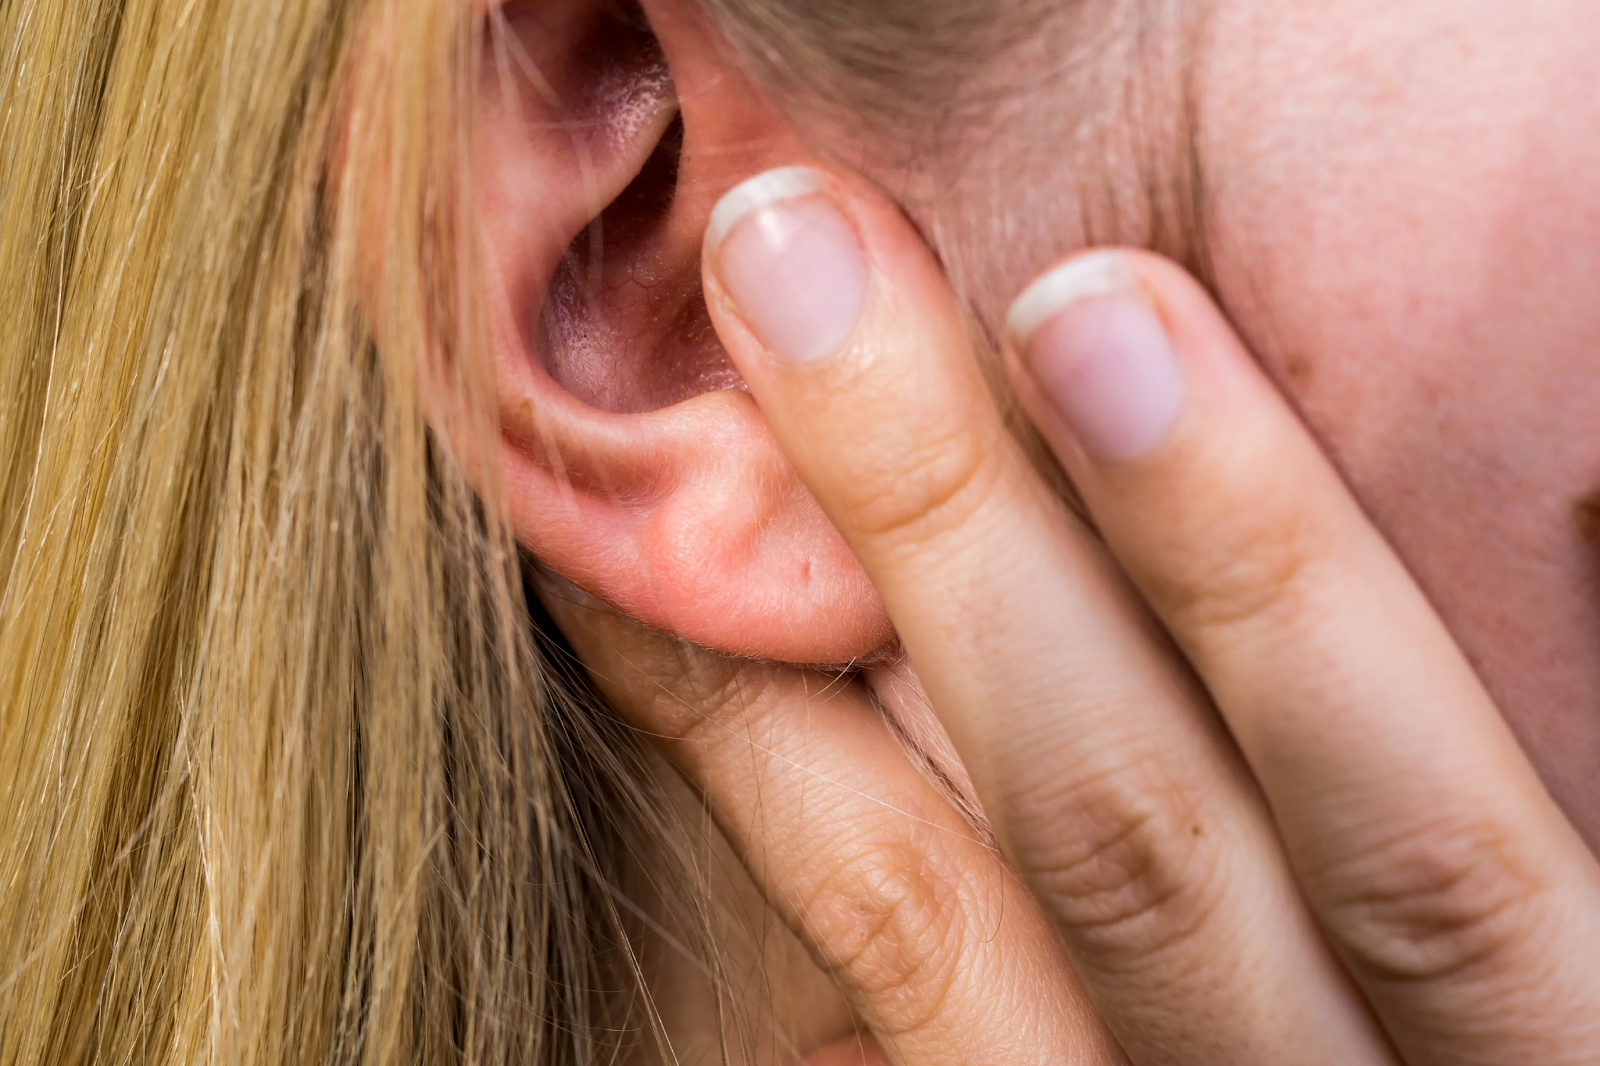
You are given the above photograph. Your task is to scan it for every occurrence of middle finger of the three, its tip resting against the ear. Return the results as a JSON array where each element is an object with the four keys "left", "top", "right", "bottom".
[{"left": 706, "top": 170, "right": 1389, "bottom": 1066}]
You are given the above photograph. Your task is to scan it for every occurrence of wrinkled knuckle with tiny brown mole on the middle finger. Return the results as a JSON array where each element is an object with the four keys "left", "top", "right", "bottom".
[{"left": 1026, "top": 763, "right": 1221, "bottom": 972}]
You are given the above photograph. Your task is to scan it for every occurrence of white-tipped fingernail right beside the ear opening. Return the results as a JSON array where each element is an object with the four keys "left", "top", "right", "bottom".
[{"left": 706, "top": 166, "right": 867, "bottom": 363}]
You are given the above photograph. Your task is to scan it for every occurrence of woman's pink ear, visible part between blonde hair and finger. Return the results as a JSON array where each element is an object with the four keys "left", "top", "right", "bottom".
[{"left": 475, "top": 0, "right": 893, "bottom": 663}]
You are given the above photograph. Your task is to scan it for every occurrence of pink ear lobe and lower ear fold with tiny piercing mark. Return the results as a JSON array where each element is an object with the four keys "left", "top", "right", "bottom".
[{"left": 504, "top": 377, "right": 891, "bottom": 663}]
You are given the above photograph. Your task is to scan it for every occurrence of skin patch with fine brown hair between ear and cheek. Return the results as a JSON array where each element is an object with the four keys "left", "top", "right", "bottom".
[{"left": 704, "top": 0, "right": 1213, "bottom": 307}]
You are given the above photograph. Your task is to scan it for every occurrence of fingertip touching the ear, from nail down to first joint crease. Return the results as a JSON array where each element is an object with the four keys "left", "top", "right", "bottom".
[{"left": 706, "top": 161, "right": 1010, "bottom": 563}]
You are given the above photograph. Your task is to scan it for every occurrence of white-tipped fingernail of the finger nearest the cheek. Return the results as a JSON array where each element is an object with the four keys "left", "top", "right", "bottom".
[{"left": 1006, "top": 251, "right": 1184, "bottom": 463}]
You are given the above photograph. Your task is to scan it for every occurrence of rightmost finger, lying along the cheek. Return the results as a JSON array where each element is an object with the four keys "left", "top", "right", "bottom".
[{"left": 1013, "top": 244, "right": 1600, "bottom": 1063}]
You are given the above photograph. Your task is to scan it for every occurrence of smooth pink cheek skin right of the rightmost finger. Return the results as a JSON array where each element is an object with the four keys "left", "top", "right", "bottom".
[{"left": 1208, "top": 0, "right": 1600, "bottom": 852}]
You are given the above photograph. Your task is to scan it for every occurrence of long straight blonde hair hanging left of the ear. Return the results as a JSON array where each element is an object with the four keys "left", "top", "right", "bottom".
[{"left": 0, "top": 0, "right": 662, "bottom": 1066}]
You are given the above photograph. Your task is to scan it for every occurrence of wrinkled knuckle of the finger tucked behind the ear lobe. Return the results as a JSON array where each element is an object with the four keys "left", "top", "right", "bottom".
[{"left": 803, "top": 842, "right": 960, "bottom": 1036}]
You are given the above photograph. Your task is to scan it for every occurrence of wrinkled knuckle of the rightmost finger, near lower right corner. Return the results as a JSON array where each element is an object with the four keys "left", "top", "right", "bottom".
[{"left": 1314, "top": 809, "right": 1546, "bottom": 984}]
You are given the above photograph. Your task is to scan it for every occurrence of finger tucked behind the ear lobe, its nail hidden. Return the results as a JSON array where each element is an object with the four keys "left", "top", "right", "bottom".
[{"left": 546, "top": 582, "right": 1125, "bottom": 1066}]
